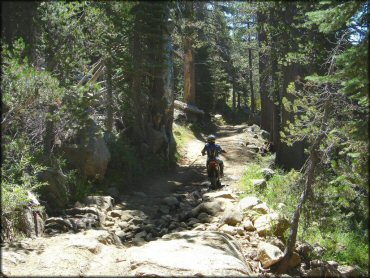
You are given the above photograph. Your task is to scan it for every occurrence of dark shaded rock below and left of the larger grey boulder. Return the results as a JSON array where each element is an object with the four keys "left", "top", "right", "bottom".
[{"left": 39, "top": 168, "right": 68, "bottom": 212}]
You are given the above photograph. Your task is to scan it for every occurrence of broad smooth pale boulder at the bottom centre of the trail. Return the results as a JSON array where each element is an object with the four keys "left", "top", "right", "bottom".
[{"left": 125, "top": 231, "right": 253, "bottom": 277}]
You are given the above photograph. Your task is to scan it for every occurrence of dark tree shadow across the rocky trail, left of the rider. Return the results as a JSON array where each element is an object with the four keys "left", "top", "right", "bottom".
[{"left": 105, "top": 165, "right": 224, "bottom": 245}]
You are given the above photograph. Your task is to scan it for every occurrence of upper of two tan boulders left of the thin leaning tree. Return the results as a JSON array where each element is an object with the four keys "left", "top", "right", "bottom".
[{"left": 254, "top": 212, "right": 289, "bottom": 236}]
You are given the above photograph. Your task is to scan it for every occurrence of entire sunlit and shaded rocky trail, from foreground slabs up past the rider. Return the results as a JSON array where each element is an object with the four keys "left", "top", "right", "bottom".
[{"left": 2, "top": 125, "right": 358, "bottom": 277}]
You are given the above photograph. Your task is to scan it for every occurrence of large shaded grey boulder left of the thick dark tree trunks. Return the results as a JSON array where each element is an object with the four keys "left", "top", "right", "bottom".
[{"left": 62, "top": 122, "right": 111, "bottom": 180}]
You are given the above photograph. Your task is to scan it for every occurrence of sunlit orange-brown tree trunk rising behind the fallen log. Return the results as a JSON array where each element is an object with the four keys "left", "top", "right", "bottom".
[{"left": 184, "top": 37, "right": 195, "bottom": 104}]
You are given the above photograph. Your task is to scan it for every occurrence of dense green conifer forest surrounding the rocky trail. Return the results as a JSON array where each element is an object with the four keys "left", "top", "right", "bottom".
[{"left": 1, "top": 1, "right": 369, "bottom": 272}]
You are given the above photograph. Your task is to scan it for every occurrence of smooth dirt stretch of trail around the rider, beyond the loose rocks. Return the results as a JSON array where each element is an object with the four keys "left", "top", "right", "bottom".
[{"left": 130, "top": 122, "right": 251, "bottom": 201}]
